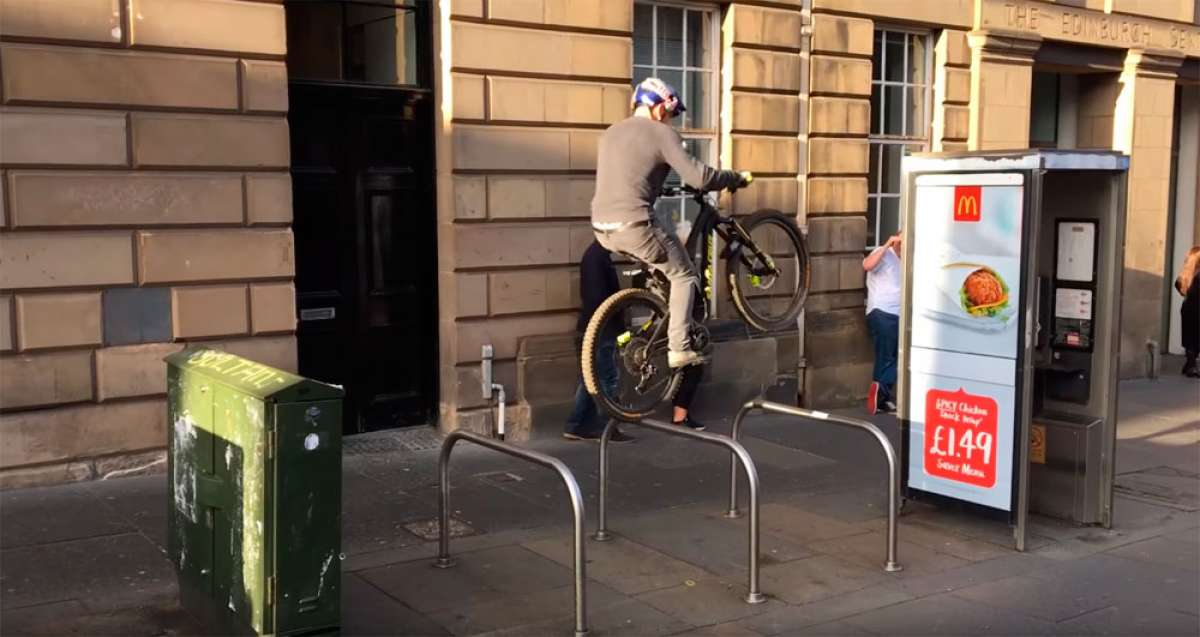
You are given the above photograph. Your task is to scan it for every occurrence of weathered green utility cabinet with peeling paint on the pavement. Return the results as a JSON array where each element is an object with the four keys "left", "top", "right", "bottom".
[{"left": 166, "top": 348, "right": 343, "bottom": 635}]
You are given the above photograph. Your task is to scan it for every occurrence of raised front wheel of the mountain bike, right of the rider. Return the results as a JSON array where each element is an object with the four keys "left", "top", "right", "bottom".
[{"left": 726, "top": 210, "right": 811, "bottom": 331}]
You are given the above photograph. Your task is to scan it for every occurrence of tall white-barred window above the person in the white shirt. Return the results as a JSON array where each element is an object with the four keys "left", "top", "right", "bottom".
[{"left": 866, "top": 29, "right": 932, "bottom": 247}]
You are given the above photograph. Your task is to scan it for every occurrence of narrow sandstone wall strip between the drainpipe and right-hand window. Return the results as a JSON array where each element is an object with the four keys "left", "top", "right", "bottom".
[{"left": 803, "top": 4, "right": 875, "bottom": 407}]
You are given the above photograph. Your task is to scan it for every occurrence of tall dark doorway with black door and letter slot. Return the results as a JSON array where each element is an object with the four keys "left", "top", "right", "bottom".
[{"left": 286, "top": 0, "right": 438, "bottom": 433}]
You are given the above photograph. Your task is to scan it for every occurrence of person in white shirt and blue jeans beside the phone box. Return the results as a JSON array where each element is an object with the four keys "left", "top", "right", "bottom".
[{"left": 863, "top": 234, "right": 904, "bottom": 414}]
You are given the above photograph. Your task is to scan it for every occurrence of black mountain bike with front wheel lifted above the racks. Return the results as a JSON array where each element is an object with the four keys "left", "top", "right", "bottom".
[{"left": 581, "top": 178, "right": 810, "bottom": 420}]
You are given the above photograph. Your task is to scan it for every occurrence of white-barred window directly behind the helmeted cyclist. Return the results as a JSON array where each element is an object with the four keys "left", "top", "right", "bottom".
[{"left": 634, "top": 1, "right": 719, "bottom": 236}]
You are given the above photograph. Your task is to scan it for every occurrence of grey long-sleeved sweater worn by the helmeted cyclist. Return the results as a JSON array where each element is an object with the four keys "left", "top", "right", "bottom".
[{"left": 592, "top": 116, "right": 740, "bottom": 223}]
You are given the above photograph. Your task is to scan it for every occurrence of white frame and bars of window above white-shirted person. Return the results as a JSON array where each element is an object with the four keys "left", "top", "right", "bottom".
[{"left": 866, "top": 24, "right": 934, "bottom": 251}]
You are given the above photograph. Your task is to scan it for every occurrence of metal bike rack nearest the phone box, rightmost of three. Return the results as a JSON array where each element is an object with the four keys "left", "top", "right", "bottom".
[{"left": 724, "top": 398, "right": 902, "bottom": 572}]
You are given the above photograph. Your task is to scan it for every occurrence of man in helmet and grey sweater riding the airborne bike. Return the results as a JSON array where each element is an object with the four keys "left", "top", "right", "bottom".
[{"left": 592, "top": 78, "right": 749, "bottom": 368}]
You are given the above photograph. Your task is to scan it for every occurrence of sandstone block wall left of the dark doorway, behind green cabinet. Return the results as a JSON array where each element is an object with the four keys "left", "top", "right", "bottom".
[{"left": 0, "top": 0, "right": 295, "bottom": 486}]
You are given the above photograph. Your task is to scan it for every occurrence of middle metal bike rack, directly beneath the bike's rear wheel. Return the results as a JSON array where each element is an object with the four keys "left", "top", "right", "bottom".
[{"left": 593, "top": 419, "right": 767, "bottom": 603}]
